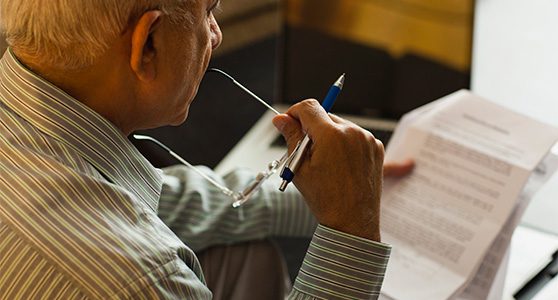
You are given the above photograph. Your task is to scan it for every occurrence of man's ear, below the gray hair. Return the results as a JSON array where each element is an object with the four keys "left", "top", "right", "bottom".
[{"left": 130, "top": 10, "right": 163, "bottom": 81}]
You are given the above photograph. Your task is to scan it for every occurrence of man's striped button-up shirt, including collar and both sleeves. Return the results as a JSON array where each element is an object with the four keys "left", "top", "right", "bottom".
[{"left": 0, "top": 51, "right": 390, "bottom": 299}]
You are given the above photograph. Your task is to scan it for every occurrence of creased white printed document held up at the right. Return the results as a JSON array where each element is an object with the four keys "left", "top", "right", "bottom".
[{"left": 381, "top": 91, "right": 558, "bottom": 300}]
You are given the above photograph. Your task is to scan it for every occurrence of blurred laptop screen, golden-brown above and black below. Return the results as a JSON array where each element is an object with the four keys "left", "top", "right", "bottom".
[{"left": 276, "top": 0, "right": 474, "bottom": 119}]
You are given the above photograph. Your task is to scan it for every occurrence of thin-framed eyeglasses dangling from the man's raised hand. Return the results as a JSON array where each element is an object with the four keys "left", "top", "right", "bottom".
[{"left": 133, "top": 68, "right": 289, "bottom": 208}]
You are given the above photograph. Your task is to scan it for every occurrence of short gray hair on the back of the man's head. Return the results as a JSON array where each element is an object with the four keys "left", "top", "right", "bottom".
[{"left": 0, "top": 0, "right": 192, "bottom": 70}]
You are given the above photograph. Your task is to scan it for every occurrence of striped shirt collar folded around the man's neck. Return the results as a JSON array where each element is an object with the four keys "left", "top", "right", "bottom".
[{"left": 0, "top": 49, "right": 162, "bottom": 210}]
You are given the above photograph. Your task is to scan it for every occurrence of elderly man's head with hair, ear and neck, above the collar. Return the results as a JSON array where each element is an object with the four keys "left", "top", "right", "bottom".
[{"left": 0, "top": 0, "right": 221, "bottom": 133}]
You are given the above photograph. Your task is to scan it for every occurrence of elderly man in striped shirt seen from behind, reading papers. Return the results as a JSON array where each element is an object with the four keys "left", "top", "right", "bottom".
[{"left": 0, "top": 0, "right": 408, "bottom": 299}]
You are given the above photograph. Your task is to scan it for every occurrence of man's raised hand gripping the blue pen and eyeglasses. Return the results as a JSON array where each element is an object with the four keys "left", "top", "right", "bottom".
[{"left": 273, "top": 100, "right": 388, "bottom": 241}]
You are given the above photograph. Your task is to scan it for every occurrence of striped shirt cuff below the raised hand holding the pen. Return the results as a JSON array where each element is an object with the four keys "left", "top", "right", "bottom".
[{"left": 293, "top": 225, "right": 391, "bottom": 299}]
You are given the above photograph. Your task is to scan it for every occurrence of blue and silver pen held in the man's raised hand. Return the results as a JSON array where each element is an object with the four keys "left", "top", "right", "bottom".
[{"left": 279, "top": 74, "right": 345, "bottom": 192}]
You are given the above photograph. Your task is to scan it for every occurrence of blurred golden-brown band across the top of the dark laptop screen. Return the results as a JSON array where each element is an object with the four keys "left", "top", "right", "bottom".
[{"left": 285, "top": 0, "right": 473, "bottom": 71}]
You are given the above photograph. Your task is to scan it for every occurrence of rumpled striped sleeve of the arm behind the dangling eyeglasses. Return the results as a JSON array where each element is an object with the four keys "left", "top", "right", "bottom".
[{"left": 158, "top": 166, "right": 317, "bottom": 251}]
